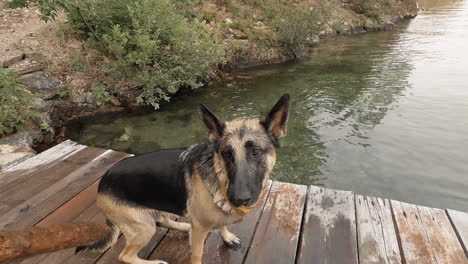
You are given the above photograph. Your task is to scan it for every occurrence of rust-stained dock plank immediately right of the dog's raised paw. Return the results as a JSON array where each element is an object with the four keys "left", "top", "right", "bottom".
[{"left": 241, "top": 181, "right": 307, "bottom": 264}]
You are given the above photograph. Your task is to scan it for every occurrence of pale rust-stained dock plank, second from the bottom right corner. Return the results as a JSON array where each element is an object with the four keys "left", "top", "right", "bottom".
[{"left": 391, "top": 201, "right": 467, "bottom": 264}]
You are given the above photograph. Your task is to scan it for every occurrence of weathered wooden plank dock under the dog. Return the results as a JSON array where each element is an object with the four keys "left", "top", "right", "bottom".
[{"left": 0, "top": 141, "right": 468, "bottom": 264}]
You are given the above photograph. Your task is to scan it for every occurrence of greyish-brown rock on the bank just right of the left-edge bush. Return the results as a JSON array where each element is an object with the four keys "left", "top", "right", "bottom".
[{"left": 17, "top": 71, "right": 63, "bottom": 99}]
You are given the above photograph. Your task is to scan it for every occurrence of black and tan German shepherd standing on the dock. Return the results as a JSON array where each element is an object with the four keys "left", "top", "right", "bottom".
[{"left": 76, "top": 94, "right": 289, "bottom": 264}]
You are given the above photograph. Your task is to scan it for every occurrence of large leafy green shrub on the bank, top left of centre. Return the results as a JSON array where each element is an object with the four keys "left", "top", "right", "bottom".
[{"left": 103, "top": 0, "right": 224, "bottom": 108}]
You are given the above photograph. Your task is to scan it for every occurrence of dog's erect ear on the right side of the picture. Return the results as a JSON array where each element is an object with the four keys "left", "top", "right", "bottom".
[{"left": 261, "top": 94, "right": 289, "bottom": 140}]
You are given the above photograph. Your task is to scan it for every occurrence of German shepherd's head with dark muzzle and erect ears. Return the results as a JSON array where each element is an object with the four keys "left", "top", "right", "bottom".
[{"left": 199, "top": 94, "right": 289, "bottom": 207}]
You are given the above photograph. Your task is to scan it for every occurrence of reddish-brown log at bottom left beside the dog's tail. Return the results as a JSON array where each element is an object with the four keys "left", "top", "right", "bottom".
[{"left": 0, "top": 223, "right": 110, "bottom": 262}]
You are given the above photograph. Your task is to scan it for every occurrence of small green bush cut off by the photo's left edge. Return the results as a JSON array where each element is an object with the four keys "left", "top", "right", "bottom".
[{"left": 0, "top": 69, "right": 35, "bottom": 134}]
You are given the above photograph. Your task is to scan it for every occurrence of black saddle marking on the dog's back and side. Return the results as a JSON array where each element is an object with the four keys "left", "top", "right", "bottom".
[{"left": 98, "top": 148, "right": 187, "bottom": 215}]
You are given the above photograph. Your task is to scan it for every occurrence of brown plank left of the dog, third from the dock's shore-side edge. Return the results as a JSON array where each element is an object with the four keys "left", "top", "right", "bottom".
[{"left": 0, "top": 150, "right": 128, "bottom": 228}]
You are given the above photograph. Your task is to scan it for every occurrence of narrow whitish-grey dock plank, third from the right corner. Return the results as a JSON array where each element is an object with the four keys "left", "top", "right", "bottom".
[{"left": 355, "top": 195, "right": 402, "bottom": 264}]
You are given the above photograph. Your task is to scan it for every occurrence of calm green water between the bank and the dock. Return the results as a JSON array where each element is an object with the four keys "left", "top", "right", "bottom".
[{"left": 71, "top": 1, "right": 468, "bottom": 211}]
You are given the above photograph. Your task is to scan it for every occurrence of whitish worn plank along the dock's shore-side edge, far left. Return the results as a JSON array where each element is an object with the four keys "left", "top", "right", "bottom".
[{"left": 0, "top": 142, "right": 86, "bottom": 193}]
